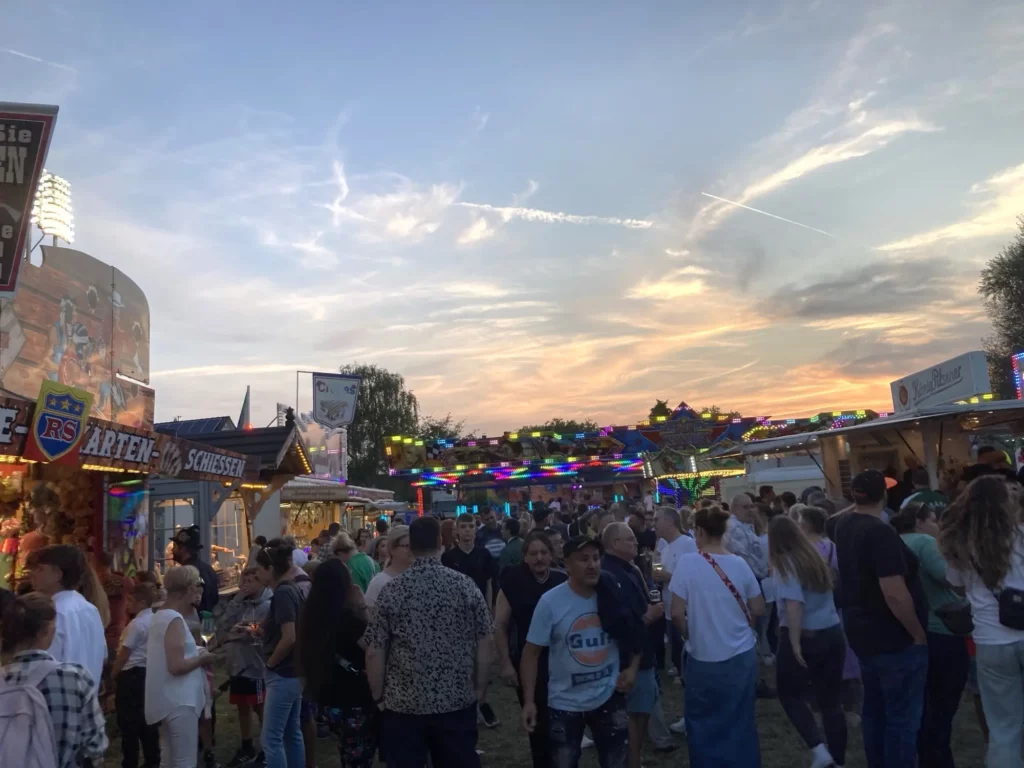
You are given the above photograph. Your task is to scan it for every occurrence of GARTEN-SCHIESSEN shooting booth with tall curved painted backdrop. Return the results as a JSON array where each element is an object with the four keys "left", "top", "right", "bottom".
[{"left": 0, "top": 240, "right": 309, "bottom": 587}]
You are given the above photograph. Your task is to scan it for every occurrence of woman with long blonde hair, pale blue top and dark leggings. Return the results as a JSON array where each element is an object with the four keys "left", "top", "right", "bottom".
[{"left": 768, "top": 515, "right": 847, "bottom": 768}]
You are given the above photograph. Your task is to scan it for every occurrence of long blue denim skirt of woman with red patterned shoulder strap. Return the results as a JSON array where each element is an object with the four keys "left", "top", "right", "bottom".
[{"left": 684, "top": 648, "right": 761, "bottom": 768}]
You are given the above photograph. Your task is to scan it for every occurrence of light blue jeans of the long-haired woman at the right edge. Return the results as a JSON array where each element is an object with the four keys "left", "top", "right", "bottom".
[{"left": 977, "top": 640, "right": 1024, "bottom": 768}]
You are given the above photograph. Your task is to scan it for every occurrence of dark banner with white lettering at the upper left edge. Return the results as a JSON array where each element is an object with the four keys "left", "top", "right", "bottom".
[{"left": 0, "top": 101, "right": 57, "bottom": 298}]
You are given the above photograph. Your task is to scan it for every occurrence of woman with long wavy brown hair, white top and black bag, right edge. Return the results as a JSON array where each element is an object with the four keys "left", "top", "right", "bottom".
[{"left": 939, "top": 475, "right": 1024, "bottom": 768}]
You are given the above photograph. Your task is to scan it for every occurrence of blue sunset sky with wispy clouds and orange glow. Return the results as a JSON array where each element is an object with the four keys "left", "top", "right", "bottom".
[{"left": 8, "top": 0, "right": 1024, "bottom": 433}]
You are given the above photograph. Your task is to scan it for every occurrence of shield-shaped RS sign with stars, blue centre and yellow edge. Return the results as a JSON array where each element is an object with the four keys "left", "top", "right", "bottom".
[{"left": 25, "top": 381, "right": 92, "bottom": 464}]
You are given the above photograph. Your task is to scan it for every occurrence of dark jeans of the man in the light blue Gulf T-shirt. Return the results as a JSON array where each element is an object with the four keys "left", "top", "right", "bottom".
[{"left": 548, "top": 693, "right": 630, "bottom": 768}]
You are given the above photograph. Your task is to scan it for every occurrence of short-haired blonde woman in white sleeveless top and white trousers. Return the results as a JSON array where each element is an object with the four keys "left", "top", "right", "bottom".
[{"left": 145, "top": 565, "right": 213, "bottom": 768}]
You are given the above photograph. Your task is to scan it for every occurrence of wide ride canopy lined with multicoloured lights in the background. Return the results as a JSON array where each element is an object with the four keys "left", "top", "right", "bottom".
[{"left": 385, "top": 402, "right": 888, "bottom": 487}]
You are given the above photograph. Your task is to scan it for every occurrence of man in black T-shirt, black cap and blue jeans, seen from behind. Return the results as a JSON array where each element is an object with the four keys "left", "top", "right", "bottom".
[{"left": 826, "top": 469, "right": 928, "bottom": 768}]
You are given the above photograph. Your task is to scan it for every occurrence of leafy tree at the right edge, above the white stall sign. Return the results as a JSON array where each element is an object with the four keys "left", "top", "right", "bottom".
[{"left": 978, "top": 216, "right": 1024, "bottom": 398}]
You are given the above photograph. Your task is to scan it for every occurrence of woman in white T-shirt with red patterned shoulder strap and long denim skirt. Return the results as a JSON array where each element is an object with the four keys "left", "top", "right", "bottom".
[{"left": 669, "top": 506, "right": 765, "bottom": 768}]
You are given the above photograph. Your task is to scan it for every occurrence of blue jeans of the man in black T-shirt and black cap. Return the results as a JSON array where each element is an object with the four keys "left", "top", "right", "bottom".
[{"left": 860, "top": 645, "right": 933, "bottom": 768}]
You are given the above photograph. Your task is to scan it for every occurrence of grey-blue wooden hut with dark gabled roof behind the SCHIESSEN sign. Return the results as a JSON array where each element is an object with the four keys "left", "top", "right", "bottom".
[{"left": 151, "top": 409, "right": 312, "bottom": 590}]
